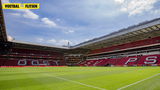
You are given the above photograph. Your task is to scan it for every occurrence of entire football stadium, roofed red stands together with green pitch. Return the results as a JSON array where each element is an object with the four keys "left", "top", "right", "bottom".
[{"left": 0, "top": 0, "right": 160, "bottom": 90}]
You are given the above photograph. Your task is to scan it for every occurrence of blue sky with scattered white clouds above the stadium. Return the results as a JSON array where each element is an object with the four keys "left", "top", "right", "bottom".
[{"left": 2, "top": 0, "right": 160, "bottom": 46}]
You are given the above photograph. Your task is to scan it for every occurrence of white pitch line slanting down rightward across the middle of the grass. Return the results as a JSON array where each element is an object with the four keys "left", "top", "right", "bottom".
[{"left": 46, "top": 74, "right": 106, "bottom": 90}]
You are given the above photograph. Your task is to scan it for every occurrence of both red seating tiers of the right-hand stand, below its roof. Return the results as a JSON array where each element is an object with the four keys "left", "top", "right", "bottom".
[{"left": 78, "top": 37, "right": 160, "bottom": 66}]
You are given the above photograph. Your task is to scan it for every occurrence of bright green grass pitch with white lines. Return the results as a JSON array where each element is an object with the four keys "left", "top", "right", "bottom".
[{"left": 0, "top": 67, "right": 160, "bottom": 90}]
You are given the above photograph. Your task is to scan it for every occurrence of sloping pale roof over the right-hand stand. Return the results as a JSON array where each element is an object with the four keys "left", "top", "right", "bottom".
[{"left": 73, "top": 18, "right": 160, "bottom": 48}]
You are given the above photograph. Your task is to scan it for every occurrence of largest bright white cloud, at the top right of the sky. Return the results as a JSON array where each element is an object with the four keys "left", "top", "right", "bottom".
[{"left": 117, "top": 0, "right": 158, "bottom": 16}]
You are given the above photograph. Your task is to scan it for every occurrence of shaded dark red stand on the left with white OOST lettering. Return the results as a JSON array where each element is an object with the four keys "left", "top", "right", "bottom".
[{"left": 0, "top": 49, "right": 65, "bottom": 66}]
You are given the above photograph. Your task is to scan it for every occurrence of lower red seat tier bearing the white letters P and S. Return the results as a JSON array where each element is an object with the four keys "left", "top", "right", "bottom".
[{"left": 79, "top": 54, "right": 160, "bottom": 66}]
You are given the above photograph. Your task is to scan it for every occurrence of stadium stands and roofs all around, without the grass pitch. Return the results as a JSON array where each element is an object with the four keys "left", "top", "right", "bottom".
[{"left": 0, "top": 2, "right": 160, "bottom": 66}]
